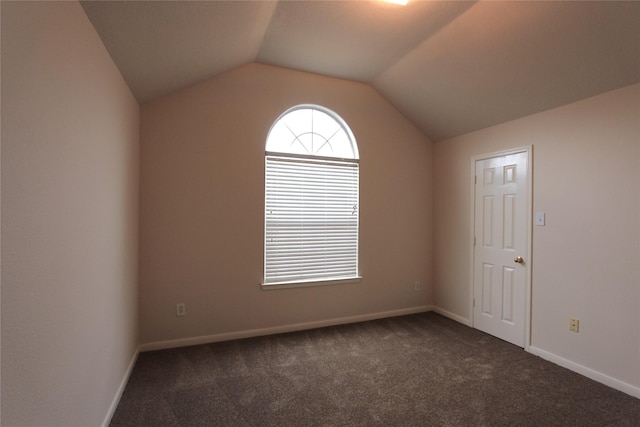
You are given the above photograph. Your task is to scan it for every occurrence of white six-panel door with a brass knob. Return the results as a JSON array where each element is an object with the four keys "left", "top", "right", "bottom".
[{"left": 473, "top": 151, "right": 530, "bottom": 347}]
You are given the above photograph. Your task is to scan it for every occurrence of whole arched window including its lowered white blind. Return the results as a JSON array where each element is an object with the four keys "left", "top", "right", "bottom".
[{"left": 264, "top": 105, "right": 359, "bottom": 287}]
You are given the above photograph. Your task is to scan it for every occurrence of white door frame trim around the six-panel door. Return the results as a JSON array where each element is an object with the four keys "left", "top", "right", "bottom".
[{"left": 469, "top": 145, "right": 533, "bottom": 351}]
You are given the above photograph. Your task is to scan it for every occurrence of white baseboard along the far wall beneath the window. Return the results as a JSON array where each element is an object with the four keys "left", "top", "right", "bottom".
[{"left": 139, "top": 305, "right": 432, "bottom": 352}]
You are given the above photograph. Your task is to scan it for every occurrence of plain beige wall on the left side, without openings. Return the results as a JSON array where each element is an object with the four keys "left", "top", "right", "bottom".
[{"left": 2, "top": 2, "right": 139, "bottom": 426}]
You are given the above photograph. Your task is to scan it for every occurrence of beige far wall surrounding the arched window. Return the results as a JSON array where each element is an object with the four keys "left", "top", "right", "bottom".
[{"left": 140, "top": 64, "right": 432, "bottom": 343}]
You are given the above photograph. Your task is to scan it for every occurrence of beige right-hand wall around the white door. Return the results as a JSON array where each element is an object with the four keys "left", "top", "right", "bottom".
[{"left": 434, "top": 85, "right": 640, "bottom": 396}]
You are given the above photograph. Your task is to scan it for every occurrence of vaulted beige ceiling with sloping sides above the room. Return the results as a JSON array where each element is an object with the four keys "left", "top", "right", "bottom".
[{"left": 81, "top": 0, "right": 640, "bottom": 141}]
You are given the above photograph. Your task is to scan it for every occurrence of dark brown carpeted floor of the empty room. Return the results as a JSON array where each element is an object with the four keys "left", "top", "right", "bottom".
[{"left": 111, "top": 313, "right": 640, "bottom": 427}]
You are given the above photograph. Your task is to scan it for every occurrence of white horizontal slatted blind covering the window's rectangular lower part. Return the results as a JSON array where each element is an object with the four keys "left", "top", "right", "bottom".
[{"left": 265, "top": 153, "right": 359, "bottom": 285}]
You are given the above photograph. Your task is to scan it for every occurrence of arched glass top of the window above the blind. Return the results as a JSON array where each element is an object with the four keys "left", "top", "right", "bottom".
[{"left": 266, "top": 105, "right": 358, "bottom": 160}]
